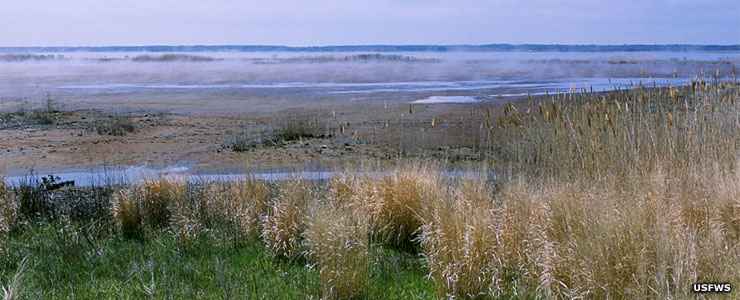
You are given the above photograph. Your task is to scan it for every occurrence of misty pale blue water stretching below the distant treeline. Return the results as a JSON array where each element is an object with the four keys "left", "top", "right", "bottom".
[{"left": 0, "top": 51, "right": 740, "bottom": 112}]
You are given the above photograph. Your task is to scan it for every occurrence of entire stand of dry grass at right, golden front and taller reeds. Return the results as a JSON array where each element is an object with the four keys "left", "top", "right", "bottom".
[{"left": 421, "top": 83, "right": 740, "bottom": 299}]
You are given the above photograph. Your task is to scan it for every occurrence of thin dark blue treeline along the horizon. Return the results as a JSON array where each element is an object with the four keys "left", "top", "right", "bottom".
[{"left": 0, "top": 44, "right": 740, "bottom": 53}]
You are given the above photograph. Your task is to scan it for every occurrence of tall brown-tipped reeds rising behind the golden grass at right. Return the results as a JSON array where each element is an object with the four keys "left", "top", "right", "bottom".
[{"left": 489, "top": 81, "right": 740, "bottom": 181}]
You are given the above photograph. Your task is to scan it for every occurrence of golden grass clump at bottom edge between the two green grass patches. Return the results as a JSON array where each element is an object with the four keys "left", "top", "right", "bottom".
[{"left": 304, "top": 205, "right": 370, "bottom": 299}]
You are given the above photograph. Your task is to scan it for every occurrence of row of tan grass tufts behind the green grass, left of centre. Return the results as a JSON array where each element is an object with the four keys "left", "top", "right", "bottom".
[{"left": 112, "top": 178, "right": 271, "bottom": 242}]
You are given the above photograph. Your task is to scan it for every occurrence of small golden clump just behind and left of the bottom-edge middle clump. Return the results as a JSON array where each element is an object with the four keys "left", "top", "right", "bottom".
[{"left": 261, "top": 179, "right": 316, "bottom": 258}]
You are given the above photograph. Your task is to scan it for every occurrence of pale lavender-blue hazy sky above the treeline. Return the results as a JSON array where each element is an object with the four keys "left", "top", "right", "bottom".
[{"left": 0, "top": 0, "right": 740, "bottom": 46}]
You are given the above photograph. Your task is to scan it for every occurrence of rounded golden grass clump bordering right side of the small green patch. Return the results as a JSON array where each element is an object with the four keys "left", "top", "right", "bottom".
[{"left": 419, "top": 182, "right": 505, "bottom": 298}]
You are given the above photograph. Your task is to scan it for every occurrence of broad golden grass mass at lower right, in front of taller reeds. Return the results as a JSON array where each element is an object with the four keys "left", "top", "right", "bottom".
[{"left": 420, "top": 172, "right": 740, "bottom": 299}]
